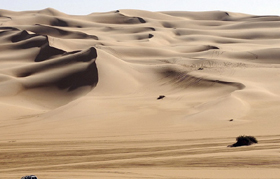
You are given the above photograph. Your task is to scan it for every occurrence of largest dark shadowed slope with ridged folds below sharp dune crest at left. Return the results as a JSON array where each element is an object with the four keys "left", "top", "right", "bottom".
[{"left": 15, "top": 47, "right": 98, "bottom": 91}]
